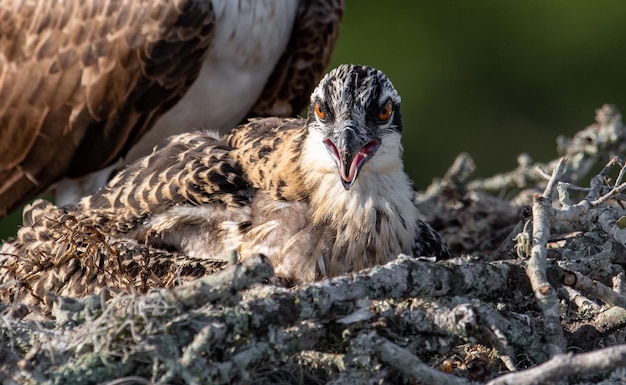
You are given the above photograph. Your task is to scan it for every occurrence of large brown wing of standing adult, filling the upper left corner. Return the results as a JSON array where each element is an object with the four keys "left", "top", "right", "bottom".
[{"left": 0, "top": 0, "right": 214, "bottom": 216}]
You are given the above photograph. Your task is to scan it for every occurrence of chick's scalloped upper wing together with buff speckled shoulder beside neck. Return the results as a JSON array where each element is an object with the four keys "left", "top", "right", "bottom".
[{"left": 12, "top": 118, "right": 304, "bottom": 256}]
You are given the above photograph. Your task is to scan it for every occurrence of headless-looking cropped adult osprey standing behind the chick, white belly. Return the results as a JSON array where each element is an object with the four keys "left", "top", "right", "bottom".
[{"left": 0, "top": 0, "right": 343, "bottom": 213}]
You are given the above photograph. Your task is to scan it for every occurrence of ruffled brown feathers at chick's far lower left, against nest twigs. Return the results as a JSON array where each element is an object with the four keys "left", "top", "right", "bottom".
[{"left": 0, "top": 200, "right": 226, "bottom": 310}]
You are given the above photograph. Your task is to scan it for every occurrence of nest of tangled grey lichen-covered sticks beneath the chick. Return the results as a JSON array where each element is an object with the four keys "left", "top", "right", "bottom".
[{"left": 0, "top": 106, "right": 626, "bottom": 384}]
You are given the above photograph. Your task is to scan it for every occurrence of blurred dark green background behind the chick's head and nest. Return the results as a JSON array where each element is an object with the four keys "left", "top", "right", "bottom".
[{"left": 0, "top": 0, "right": 626, "bottom": 239}]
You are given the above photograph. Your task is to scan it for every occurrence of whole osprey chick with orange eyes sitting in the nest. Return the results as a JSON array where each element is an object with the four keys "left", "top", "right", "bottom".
[{"left": 0, "top": 65, "right": 449, "bottom": 306}]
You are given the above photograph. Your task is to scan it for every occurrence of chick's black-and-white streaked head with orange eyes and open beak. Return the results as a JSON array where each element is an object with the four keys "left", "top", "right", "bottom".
[{"left": 308, "top": 64, "right": 402, "bottom": 190}]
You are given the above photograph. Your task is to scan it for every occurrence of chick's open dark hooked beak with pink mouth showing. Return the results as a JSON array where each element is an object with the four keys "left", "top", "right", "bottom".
[{"left": 324, "top": 127, "right": 380, "bottom": 190}]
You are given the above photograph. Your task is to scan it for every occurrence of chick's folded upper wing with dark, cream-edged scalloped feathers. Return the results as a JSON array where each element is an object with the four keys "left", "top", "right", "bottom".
[{"left": 76, "top": 132, "right": 253, "bottom": 234}]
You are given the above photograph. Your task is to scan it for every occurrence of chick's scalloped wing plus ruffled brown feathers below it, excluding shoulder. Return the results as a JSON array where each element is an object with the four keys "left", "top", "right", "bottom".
[{"left": 0, "top": 132, "right": 254, "bottom": 303}]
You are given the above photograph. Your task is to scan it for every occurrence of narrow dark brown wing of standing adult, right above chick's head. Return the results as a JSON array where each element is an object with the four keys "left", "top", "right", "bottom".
[{"left": 249, "top": 0, "right": 344, "bottom": 117}]
